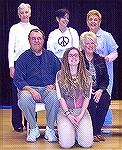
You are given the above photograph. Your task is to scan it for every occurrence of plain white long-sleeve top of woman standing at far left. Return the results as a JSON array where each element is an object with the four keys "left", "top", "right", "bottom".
[{"left": 8, "top": 22, "right": 38, "bottom": 68}]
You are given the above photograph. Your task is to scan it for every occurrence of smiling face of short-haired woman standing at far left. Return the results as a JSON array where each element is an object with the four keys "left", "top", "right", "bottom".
[{"left": 18, "top": 6, "right": 31, "bottom": 23}]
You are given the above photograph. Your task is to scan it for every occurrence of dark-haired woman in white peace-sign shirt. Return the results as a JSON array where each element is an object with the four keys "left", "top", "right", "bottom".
[{"left": 47, "top": 9, "right": 79, "bottom": 59}]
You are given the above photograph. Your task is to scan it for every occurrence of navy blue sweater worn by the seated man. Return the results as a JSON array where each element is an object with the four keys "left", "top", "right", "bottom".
[{"left": 13, "top": 49, "right": 61, "bottom": 90}]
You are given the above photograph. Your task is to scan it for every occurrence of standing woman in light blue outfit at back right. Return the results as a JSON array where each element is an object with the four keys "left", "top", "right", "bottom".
[{"left": 86, "top": 9, "right": 118, "bottom": 129}]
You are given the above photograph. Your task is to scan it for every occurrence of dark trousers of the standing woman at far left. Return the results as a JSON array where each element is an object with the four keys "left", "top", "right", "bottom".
[{"left": 12, "top": 83, "right": 27, "bottom": 129}]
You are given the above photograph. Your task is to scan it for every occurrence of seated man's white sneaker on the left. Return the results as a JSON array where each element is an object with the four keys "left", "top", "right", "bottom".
[{"left": 26, "top": 127, "right": 40, "bottom": 142}]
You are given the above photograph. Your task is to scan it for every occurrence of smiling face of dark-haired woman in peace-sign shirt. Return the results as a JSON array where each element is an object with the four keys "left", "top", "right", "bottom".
[{"left": 56, "top": 13, "right": 69, "bottom": 28}]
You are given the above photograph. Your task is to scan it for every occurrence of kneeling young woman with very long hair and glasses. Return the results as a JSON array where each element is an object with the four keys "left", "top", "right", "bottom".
[{"left": 56, "top": 47, "right": 93, "bottom": 148}]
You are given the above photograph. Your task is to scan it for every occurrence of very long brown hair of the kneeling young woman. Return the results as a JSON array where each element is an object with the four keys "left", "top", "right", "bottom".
[{"left": 58, "top": 47, "right": 91, "bottom": 97}]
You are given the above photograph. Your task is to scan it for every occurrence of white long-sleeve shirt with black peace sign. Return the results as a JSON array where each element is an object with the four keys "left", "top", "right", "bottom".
[{"left": 47, "top": 27, "right": 79, "bottom": 58}]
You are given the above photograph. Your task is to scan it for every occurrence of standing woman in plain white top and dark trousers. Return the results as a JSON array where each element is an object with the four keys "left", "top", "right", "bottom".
[{"left": 8, "top": 3, "right": 38, "bottom": 132}]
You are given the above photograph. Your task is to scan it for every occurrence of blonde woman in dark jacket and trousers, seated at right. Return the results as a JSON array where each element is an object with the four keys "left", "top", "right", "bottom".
[{"left": 80, "top": 31, "right": 110, "bottom": 142}]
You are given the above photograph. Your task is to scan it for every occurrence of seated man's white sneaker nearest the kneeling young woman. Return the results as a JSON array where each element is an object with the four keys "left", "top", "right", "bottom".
[{"left": 44, "top": 126, "right": 58, "bottom": 142}]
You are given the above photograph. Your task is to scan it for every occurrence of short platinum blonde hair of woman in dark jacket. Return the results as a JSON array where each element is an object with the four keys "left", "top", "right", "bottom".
[{"left": 80, "top": 31, "right": 97, "bottom": 50}]
